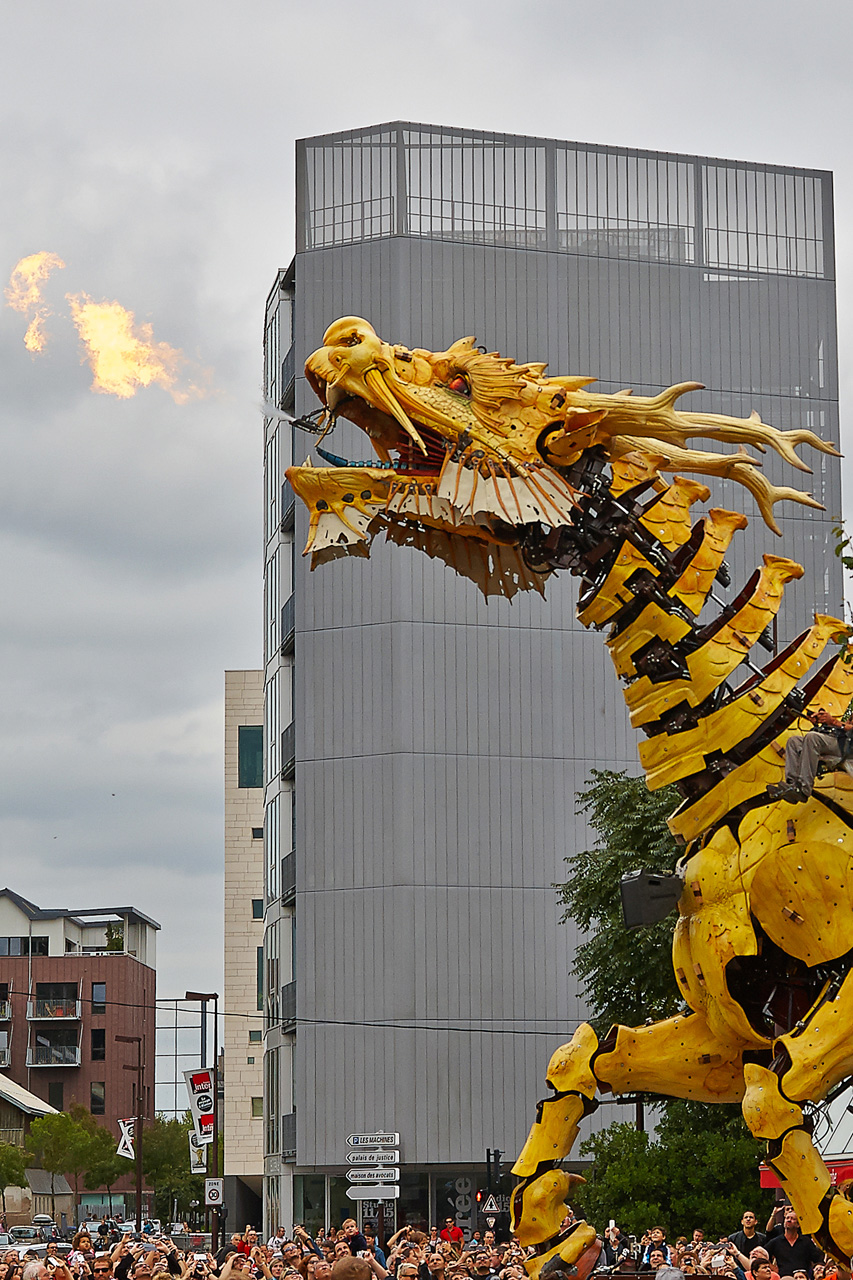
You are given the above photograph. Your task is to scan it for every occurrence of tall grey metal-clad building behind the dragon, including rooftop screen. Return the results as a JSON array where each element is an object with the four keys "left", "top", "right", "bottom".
[{"left": 264, "top": 123, "right": 841, "bottom": 1226}]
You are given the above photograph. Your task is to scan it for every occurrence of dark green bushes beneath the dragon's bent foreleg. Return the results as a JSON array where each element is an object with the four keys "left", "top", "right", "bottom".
[{"left": 574, "top": 1098, "right": 774, "bottom": 1239}]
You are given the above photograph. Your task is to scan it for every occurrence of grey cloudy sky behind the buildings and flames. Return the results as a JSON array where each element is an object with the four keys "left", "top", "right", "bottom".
[{"left": 0, "top": 0, "right": 853, "bottom": 1013}]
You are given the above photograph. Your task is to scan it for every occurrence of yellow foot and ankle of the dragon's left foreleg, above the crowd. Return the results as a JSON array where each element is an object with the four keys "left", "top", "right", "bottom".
[{"left": 512, "top": 1169, "right": 601, "bottom": 1280}]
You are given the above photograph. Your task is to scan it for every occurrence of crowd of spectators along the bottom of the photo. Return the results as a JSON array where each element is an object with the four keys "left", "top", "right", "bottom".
[{"left": 0, "top": 1206, "right": 838, "bottom": 1280}]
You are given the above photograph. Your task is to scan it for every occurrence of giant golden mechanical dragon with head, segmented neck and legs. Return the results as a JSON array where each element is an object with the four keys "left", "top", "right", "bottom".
[{"left": 287, "top": 316, "right": 853, "bottom": 1280}]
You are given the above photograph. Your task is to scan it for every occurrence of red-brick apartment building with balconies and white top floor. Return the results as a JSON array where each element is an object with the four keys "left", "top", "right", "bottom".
[{"left": 0, "top": 888, "right": 160, "bottom": 1135}]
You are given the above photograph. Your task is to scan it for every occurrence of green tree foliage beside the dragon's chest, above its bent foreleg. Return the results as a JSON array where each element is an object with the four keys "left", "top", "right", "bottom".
[{"left": 555, "top": 769, "right": 681, "bottom": 1036}]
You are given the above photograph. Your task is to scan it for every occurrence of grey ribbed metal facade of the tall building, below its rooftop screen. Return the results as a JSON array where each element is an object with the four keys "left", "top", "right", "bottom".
[{"left": 281, "top": 137, "right": 840, "bottom": 1167}]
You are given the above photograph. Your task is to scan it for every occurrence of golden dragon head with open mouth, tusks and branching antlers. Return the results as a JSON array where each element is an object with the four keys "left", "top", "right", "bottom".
[{"left": 287, "top": 316, "right": 835, "bottom": 596}]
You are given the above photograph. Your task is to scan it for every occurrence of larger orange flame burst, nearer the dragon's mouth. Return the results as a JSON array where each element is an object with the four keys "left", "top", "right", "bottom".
[{"left": 68, "top": 293, "right": 201, "bottom": 404}]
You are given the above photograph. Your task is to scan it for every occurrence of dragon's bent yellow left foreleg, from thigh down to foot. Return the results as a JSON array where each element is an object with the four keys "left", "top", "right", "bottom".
[{"left": 512, "top": 1014, "right": 744, "bottom": 1280}]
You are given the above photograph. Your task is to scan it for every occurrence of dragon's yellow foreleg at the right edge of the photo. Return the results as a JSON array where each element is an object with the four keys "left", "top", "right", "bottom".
[{"left": 743, "top": 974, "right": 853, "bottom": 1267}]
